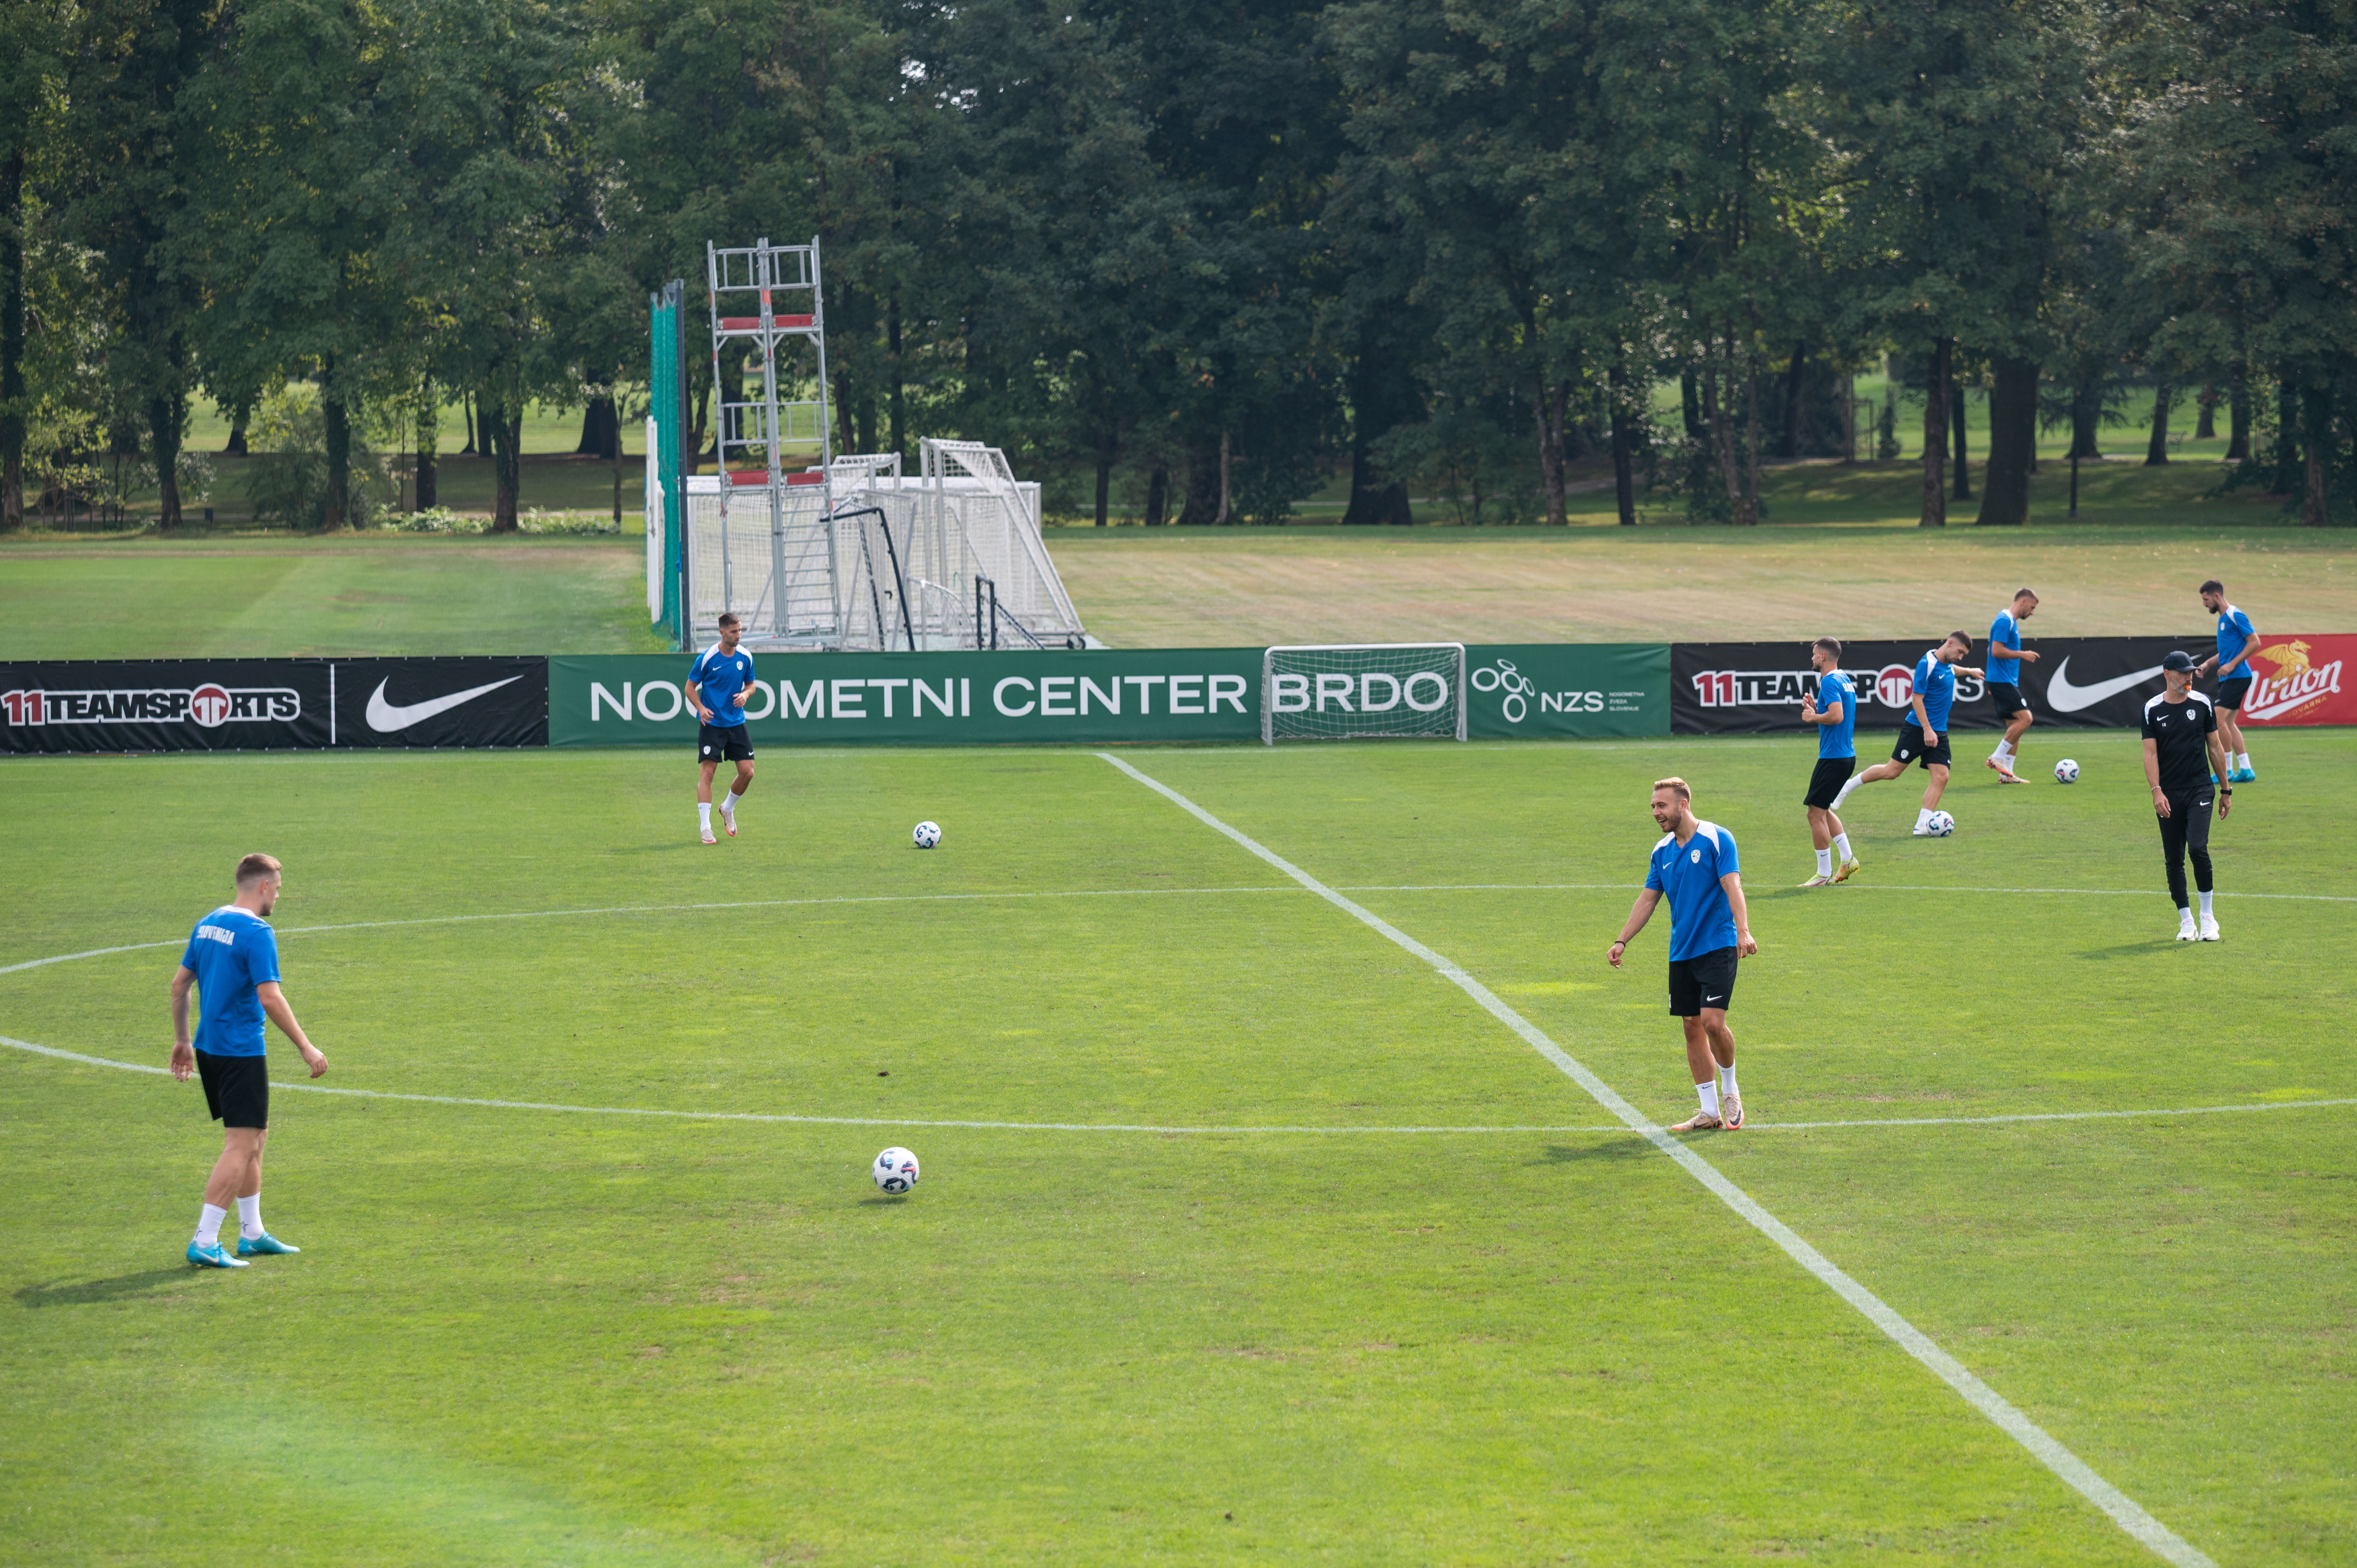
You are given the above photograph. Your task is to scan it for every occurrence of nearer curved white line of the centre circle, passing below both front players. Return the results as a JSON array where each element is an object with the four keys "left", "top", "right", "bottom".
[{"left": 0, "top": 1035, "right": 2357, "bottom": 1136}]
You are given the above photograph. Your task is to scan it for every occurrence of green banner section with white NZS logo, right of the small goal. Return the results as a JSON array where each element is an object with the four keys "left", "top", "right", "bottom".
[{"left": 1466, "top": 641, "right": 1669, "bottom": 738}]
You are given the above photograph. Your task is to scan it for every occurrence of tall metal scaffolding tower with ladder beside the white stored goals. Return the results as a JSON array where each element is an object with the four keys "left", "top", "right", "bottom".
[{"left": 705, "top": 234, "right": 844, "bottom": 646}]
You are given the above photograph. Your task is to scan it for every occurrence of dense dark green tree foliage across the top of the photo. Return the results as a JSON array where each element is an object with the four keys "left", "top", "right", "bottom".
[{"left": 0, "top": 0, "right": 2357, "bottom": 526}]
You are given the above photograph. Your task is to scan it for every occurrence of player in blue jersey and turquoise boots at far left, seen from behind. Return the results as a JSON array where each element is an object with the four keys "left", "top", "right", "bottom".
[{"left": 172, "top": 856, "right": 328, "bottom": 1268}]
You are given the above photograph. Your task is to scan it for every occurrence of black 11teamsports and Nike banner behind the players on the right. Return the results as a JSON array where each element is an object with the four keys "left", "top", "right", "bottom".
[{"left": 1669, "top": 632, "right": 2234, "bottom": 735}]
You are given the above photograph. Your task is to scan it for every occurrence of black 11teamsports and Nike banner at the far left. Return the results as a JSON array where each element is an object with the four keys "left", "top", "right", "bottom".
[{"left": 0, "top": 658, "right": 549, "bottom": 752}]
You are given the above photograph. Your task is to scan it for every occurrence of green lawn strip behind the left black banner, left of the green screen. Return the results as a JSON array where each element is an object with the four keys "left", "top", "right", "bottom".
[{"left": 0, "top": 533, "right": 665, "bottom": 658}]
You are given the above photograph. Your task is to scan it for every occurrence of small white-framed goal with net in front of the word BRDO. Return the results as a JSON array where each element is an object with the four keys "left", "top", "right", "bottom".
[{"left": 1261, "top": 641, "right": 1466, "bottom": 745}]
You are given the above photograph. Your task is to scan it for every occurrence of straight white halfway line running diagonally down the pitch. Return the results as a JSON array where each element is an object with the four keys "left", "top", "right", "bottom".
[{"left": 1098, "top": 752, "right": 2216, "bottom": 1568}]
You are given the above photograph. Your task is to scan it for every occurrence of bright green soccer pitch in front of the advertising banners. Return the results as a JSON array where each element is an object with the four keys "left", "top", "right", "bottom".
[{"left": 0, "top": 731, "right": 2357, "bottom": 1566}]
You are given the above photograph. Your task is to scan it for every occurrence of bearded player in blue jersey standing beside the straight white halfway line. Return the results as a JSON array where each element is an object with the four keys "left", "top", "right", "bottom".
[{"left": 1605, "top": 778, "right": 1761, "bottom": 1132}]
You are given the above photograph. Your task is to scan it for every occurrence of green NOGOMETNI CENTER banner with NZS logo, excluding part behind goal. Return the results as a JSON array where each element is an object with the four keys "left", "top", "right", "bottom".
[{"left": 549, "top": 644, "right": 1669, "bottom": 747}]
